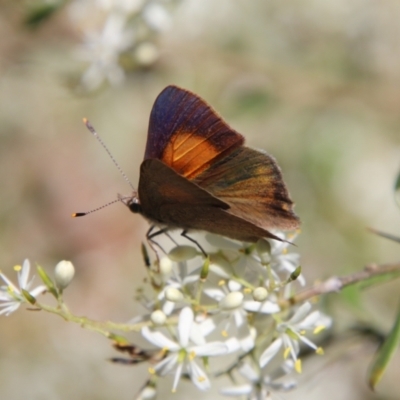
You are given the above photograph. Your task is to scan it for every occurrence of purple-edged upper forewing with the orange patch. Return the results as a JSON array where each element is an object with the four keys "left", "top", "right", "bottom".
[{"left": 144, "top": 86, "right": 244, "bottom": 179}]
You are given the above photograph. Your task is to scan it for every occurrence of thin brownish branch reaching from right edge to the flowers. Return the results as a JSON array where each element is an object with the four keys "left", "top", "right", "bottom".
[{"left": 279, "top": 263, "right": 400, "bottom": 308}]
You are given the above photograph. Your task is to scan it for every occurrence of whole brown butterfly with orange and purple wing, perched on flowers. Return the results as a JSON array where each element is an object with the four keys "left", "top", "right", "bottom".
[{"left": 121, "top": 86, "right": 300, "bottom": 254}]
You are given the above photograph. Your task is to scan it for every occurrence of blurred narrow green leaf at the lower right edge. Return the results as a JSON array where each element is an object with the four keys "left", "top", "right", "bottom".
[{"left": 368, "top": 305, "right": 400, "bottom": 390}]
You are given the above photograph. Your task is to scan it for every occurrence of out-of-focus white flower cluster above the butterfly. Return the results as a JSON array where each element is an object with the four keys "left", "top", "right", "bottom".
[{"left": 69, "top": 0, "right": 180, "bottom": 91}]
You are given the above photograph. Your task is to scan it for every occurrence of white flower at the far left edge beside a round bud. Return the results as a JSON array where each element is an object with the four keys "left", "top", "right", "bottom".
[{"left": 0, "top": 260, "right": 46, "bottom": 315}]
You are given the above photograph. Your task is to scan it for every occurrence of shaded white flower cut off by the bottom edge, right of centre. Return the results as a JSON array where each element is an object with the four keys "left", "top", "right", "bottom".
[{"left": 221, "top": 361, "right": 296, "bottom": 400}]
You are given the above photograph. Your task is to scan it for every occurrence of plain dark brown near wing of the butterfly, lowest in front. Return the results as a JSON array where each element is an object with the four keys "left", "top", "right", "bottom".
[{"left": 139, "top": 159, "right": 281, "bottom": 242}]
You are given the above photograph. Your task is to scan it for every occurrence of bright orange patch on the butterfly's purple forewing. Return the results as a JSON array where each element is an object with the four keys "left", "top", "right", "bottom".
[{"left": 161, "top": 132, "right": 220, "bottom": 179}]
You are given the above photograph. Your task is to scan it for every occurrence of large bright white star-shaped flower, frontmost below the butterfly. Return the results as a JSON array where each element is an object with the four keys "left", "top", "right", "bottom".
[{"left": 142, "top": 307, "right": 228, "bottom": 392}]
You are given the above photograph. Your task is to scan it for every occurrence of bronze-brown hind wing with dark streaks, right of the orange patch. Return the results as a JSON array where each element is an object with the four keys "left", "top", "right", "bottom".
[{"left": 194, "top": 146, "right": 299, "bottom": 230}]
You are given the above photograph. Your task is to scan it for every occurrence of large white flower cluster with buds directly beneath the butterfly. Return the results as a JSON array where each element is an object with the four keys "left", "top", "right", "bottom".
[{"left": 134, "top": 235, "right": 331, "bottom": 399}]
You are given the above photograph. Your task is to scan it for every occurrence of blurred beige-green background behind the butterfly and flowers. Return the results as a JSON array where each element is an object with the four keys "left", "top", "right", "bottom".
[{"left": 0, "top": 0, "right": 400, "bottom": 400}]
